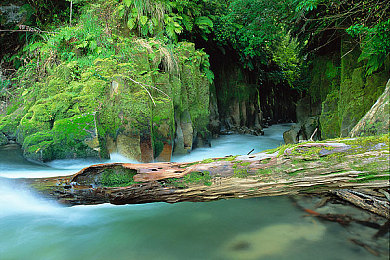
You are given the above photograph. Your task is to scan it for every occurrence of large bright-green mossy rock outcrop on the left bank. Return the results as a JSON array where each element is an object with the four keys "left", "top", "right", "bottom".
[{"left": 0, "top": 39, "right": 209, "bottom": 162}]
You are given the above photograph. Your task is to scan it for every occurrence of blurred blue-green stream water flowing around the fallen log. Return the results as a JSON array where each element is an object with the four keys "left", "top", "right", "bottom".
[{"left": 0, "top": 125, "right": 386, "bottom": 260}]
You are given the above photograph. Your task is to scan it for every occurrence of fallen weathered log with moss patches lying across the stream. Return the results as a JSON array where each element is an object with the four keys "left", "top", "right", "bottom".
[{"left": 23, "top": 134, "right": 390, "bottom": 215}]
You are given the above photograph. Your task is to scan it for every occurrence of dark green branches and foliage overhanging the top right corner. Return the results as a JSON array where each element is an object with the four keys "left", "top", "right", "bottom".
[{"left": 288, "top": 0, "right": 390, "bottom": 75}]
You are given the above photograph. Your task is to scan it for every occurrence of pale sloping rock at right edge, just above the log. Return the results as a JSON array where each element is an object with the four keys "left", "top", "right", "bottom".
[{"left": 349, "top": 79, "right": 390, "bottom": 137}]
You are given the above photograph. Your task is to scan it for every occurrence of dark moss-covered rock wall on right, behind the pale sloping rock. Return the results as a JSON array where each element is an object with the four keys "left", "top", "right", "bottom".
[{"left": 297, "top": 36, "right": 390, "bottom": 139}]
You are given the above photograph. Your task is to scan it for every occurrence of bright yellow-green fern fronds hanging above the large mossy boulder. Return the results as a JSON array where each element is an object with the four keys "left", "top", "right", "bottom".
[{"left": 117, "top": 0, "right": 216, "bottom": 42}]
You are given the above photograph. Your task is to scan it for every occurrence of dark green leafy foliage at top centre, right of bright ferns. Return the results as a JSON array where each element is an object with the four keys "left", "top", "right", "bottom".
[{"left": 215, "top": 0, "right": 282, "bottom": 69}]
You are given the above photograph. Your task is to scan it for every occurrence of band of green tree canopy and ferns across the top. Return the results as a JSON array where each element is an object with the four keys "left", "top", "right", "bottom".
[{"left": 1, "top": 0, "right": 390, "bottom": 91}]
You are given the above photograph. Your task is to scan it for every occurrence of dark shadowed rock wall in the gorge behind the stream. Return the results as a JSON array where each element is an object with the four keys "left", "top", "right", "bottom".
[{"left": 210, "top": 55, "right": 296, "bottom": 135}]
